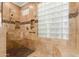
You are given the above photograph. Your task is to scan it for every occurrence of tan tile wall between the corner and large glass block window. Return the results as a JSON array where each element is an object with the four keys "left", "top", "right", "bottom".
[{"left": 20, "top": 3, "right": 37, "bottom": 40}]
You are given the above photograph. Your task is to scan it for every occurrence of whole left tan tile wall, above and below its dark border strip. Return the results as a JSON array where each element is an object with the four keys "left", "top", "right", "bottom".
[{"left": 3, "top": 2, "right": 20, "bottom": 31}]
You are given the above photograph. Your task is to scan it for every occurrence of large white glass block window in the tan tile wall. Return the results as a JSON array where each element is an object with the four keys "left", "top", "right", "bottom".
[{"left": 38, "top": 2, "right": 69, "bottom": 39}]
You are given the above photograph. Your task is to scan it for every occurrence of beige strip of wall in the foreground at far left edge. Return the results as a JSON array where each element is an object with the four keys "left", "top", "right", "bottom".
[{"left": 0, "top": 11, "right": 6, "bottom": 56}]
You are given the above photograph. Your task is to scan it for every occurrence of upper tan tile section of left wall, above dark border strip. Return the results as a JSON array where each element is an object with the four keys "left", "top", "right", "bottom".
[{"left": 3, "top": 2, "right": 21, "bottom": 21}]
